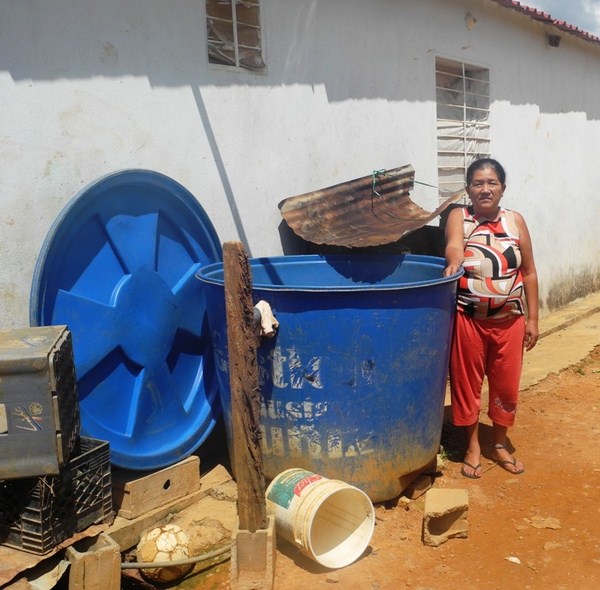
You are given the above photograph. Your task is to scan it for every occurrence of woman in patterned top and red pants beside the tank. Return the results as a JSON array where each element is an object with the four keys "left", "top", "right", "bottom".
[{"left": 444, "top": 158, "right": 539, "bottom": 479}]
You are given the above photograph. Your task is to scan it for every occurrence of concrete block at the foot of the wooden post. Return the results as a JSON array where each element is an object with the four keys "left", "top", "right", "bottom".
[{"left": 230, "top": 515, "right": 276, "bottom": 590}]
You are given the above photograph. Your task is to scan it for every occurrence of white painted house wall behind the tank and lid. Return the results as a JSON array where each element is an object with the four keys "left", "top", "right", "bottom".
[{"left": 0, "top": 0, "right": 600, "bottom": 327}]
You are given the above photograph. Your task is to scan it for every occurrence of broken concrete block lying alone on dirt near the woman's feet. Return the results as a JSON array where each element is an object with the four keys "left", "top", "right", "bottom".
[{"left": 423, "top": 488, "right": 469, "bottom": 547}]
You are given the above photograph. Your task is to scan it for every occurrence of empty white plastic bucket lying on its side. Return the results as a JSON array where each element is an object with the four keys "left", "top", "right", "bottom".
[{"left": 266, "top": 468, "right": 375, "bottom": 568}]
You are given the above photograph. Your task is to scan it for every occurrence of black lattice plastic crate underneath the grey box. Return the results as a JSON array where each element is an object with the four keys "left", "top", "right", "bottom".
[{"left": 0, "top": 437, "right": 114, "bottom": 555}]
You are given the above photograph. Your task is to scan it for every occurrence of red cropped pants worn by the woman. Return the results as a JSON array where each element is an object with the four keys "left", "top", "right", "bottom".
[{"left": 450, "top": 312, "right": 525, "bottom": 426}]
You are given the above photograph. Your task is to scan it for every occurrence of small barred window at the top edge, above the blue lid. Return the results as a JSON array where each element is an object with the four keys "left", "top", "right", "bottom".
[{"left": 206, "top": 0, "right": 265, "bottom": 71}]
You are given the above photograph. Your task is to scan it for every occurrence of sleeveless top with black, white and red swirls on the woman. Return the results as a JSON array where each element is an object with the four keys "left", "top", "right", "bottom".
[{"left": 458, "top": 207, "right": 525, "bottom": 320}]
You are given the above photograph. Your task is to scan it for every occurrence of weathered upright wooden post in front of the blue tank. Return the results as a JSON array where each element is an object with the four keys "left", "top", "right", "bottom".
[{"left": 223, "top": 242, "right": 267, "bottom": 533}]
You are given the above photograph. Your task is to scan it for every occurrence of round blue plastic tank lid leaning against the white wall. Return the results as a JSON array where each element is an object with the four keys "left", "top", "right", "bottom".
[{"left": 30, "top": 170, "right": 222, "bottom": 470}]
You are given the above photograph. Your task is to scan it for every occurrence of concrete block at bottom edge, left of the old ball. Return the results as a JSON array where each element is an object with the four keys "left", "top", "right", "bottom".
[{"left": 65, "top": 533, "right": 121, "bottom": 590}]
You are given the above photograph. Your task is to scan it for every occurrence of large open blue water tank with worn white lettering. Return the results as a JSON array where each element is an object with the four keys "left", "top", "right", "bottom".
[{"left": 197, "top": 255, "right": 460, "bottom": 502}]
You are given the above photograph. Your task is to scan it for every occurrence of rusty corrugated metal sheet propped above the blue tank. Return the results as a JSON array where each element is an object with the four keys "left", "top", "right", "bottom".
[{"left": 279, "top": 165, "right": 464, "bottom": 248}]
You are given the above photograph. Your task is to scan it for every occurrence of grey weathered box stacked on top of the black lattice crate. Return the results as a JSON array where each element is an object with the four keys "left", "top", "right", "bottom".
[{"left": 0, "top": 326, "right": 80, "bottom": 480}]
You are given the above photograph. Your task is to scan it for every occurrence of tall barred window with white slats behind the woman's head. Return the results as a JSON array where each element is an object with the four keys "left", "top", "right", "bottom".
[{"left": 435, "top": 58, "right": 490, "bottom": 200}]
